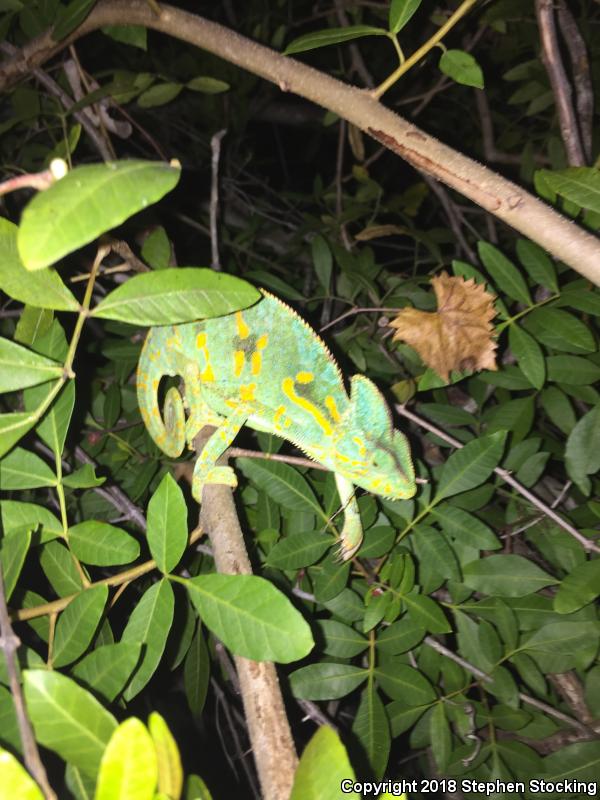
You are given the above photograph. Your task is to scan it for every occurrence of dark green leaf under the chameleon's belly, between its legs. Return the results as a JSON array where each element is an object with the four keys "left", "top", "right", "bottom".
[{"left": 236, "top": 458, "right": 325, "bottom": 518}]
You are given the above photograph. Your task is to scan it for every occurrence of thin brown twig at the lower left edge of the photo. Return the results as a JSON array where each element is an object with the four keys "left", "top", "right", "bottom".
[{"left": 0, "top": 564, "right": 56, "bottom": 800}]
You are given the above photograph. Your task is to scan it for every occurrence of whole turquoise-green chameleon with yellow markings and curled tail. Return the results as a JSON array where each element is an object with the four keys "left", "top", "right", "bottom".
[{"left": 137, "top": 289, "right": 416, "bottom": 560}]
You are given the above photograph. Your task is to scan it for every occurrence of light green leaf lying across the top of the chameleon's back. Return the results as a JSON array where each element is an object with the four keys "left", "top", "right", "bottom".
[{"left": 91, "top": 267, "right": 260, "bottom": 325}]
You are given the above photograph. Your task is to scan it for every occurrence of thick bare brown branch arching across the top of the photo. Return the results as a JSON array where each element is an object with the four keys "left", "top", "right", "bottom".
[{"left": 0, "top": 0, "right": 600, "bottom": 285}]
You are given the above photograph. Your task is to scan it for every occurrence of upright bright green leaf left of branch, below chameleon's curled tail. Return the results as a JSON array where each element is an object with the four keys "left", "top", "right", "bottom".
[{"left": 146, "top": 472, "right": 188, "bottom": 573}]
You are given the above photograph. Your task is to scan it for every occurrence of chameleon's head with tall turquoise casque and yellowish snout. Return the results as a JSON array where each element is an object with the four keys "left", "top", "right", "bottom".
[{"left": 335, "top": 375, "right": 416, "bottom": 500}]
